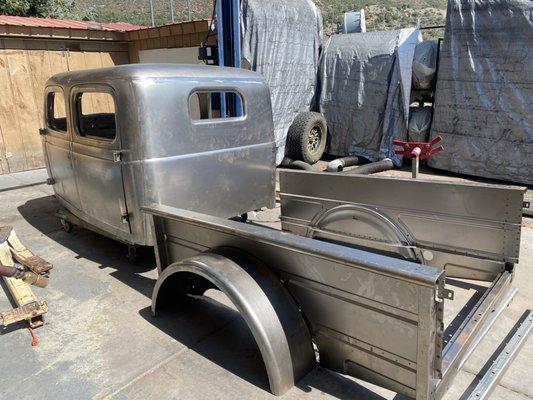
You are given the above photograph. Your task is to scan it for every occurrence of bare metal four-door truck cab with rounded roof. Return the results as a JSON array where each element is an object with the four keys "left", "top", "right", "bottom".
[{"left": 41, "top": 64, "right": 275, "bottom": 245}]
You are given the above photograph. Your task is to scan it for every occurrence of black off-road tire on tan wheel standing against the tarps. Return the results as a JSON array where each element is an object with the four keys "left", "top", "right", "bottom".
[{"left": 286, "top": 112, "right": 328, "bottom": 165}]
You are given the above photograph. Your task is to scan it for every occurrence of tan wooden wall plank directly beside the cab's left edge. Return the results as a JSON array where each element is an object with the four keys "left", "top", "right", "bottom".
[{"left": 7, "top": 50, "right": 44, "bottom": 169}]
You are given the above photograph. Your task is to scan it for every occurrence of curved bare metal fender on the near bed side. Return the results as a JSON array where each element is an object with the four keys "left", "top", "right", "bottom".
[{"left": 152, "top": 249, "right": 316, "bottom": 396}]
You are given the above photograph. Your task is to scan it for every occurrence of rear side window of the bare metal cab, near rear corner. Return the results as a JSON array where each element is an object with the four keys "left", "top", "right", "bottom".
[{"left": 74, "top": 91, "right": 117, "bottom": 141}]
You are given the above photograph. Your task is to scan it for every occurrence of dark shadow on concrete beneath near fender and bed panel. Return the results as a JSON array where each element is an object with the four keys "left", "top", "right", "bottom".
[{"left": 139, "top": 290, "right": 405, "bottom": 400}]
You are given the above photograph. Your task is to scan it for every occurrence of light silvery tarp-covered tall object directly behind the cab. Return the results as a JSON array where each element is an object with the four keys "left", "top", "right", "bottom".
[{"left": 241, "top": 0, "right": 322, "bottom": 164}]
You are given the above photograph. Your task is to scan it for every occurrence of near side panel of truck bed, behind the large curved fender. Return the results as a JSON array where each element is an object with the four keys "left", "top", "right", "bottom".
[{"left": 145, "top": 206, "right": 443, "bottom": 399}]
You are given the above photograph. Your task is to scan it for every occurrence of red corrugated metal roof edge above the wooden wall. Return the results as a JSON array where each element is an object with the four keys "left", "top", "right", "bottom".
[{"left": 0, "top": 15, "right": 146, "bottom": 32}]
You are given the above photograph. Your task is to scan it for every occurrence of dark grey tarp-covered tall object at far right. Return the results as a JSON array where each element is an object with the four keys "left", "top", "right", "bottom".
[{"left": 429, "top": 0, "right": 533, "bottom": 185}]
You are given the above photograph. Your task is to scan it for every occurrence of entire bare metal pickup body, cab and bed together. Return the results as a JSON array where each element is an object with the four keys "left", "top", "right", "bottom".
[{"left": 43, "top": 66, "right": 533, "bottom": 400}]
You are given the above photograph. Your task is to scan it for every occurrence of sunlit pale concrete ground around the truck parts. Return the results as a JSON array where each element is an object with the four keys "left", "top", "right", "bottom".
[{"left": 0, "top": 170, "right": 533, "bottom": 400}]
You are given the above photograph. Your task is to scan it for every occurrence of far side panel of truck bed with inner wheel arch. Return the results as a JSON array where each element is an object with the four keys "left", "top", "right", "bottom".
[{"left": 280, "top": 171, "right": 525, "bottom": 280}]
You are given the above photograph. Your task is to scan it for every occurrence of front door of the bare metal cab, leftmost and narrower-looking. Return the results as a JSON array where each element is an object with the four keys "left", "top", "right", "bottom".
[{"left": 43, "top": 86, "right": 80, "bottom": 208}]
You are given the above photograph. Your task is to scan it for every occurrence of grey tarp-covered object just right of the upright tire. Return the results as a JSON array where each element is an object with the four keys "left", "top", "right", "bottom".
[{"left": 319, "top": 28, "right": 420, "bottom": 165}]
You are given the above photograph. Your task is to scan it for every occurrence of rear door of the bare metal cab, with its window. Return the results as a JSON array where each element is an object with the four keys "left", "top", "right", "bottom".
[{"left": 71, "top": 85, "right": 131, "bottom": 238}]
